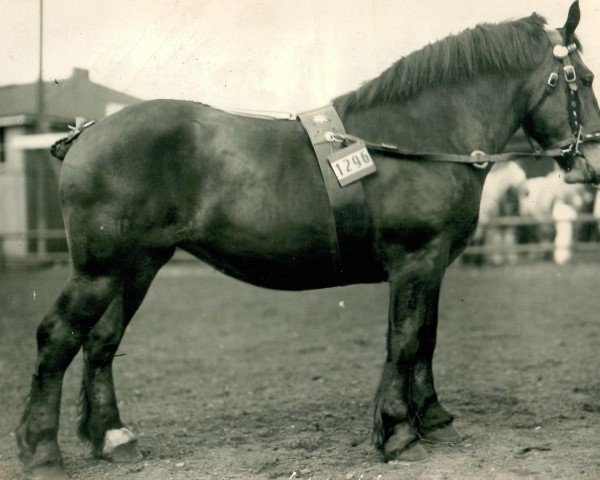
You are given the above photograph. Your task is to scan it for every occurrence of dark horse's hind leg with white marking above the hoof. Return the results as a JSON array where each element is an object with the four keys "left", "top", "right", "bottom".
[{"left": 78, "top": 250, "right": 173, "bottom": 462}]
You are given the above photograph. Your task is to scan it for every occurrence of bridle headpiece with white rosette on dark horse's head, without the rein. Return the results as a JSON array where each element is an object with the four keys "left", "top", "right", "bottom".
[{"left": 525, "top": 30, "right": 600, "bottom": 185}]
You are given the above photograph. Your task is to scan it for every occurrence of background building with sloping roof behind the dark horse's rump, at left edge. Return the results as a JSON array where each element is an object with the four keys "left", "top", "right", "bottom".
[{"left": 0, "top": 68, "right": 140, "bottom": 256}]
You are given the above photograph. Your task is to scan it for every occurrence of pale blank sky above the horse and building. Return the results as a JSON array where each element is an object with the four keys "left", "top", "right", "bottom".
[{"left": 0, "top": 0, "right": 600, "bottom": 112}]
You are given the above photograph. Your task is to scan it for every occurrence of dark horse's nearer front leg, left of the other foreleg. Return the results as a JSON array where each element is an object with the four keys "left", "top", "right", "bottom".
[{"left": 374, "top": 245, "right": 451, "bottom": 461}]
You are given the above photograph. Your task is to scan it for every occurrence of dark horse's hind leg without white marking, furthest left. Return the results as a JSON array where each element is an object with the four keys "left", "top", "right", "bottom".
[{"left": 16, "top": 271, "right": 117, "bottom": 479}]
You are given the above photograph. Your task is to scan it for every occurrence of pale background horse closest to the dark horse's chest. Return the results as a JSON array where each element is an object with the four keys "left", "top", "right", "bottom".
[{"left": 471, "top": 162, "right": 527, "bottom": 265}]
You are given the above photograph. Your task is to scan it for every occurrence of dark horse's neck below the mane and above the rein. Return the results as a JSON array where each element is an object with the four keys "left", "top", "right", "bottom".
[{"left": 342, "top": 76, "right": 528, "bottom": 154}]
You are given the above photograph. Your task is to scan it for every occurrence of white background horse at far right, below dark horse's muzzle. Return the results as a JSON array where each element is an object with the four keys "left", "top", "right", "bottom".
[{"left": 519, "top": 171, "right": 594, "bottom": 264}]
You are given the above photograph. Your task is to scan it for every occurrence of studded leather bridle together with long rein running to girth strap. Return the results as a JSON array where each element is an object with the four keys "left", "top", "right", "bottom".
[{"left": 326, "top": 30, "right": 600, "bottom": 180}]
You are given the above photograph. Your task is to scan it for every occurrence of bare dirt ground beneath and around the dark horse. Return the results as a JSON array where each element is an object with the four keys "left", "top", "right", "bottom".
[{"left": 0, "top": 263, "right": 600, "bottom": 480}]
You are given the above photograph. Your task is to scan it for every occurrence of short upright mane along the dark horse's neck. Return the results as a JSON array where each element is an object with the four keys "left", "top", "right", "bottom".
[{"left": 333, "top": 13, "right": 546, "bottom": 114}]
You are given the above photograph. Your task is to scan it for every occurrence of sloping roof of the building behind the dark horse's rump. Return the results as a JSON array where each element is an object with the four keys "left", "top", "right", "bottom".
[{"left": 0, "top": 68, "right": 141, "bottom": 126}]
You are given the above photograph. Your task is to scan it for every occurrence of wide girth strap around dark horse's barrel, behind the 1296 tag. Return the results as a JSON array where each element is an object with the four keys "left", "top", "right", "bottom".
[{"left": 298, "top": 105, "right": 380, "bottom": 285}]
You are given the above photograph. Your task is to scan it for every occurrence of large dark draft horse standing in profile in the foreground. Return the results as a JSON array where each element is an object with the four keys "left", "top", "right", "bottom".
[{"left": 17, "top": 3, "right": 600, "bottom": 478}]
